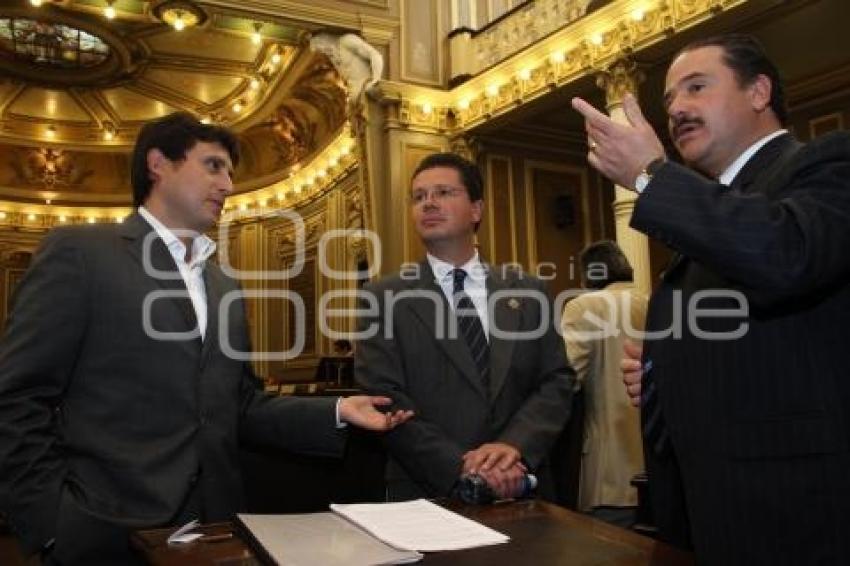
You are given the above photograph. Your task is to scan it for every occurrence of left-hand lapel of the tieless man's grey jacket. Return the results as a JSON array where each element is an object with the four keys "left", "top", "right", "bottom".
[{"left": 120, "top": 214, "right": 198, "bottom": 338}]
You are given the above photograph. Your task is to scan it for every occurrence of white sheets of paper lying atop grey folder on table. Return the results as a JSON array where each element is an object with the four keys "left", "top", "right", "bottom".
[{"left": 331, "top": 499, "right": 510, "bottom": 552}]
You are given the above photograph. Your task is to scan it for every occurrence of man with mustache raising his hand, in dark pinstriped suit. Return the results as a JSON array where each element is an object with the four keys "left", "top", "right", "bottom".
[{"left": 573, "top": 34, "right": 850, "bottom": 566}]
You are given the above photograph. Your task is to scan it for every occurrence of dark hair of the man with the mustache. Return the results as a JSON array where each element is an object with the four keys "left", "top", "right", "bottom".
[{"left": 679, "top": 33, "right": 788, "bottom": 126}]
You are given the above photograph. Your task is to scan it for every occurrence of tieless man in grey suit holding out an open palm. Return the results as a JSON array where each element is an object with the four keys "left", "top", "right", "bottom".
[{"left": 0, "top": 113, "right": 409, "bottom": 566}]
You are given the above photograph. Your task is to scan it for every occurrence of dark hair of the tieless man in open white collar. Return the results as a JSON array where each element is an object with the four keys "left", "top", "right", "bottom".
[{"left": 130, "top": 112, "right": 239, "bottom": 206}]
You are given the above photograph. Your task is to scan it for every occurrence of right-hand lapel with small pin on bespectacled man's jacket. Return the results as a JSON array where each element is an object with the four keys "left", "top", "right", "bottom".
[{"left": 487, "top": 266, "right": 522, "bottom": 399}]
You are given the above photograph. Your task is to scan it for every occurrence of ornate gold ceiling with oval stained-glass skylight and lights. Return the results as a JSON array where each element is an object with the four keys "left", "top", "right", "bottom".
[{"left": 0, "top": 0, "right": 346, "bottom": 205}]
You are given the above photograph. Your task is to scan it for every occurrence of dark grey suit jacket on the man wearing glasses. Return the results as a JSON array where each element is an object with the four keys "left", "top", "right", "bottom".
[{"left": 354, "top": 261, "right": 574, "bottom": 500}]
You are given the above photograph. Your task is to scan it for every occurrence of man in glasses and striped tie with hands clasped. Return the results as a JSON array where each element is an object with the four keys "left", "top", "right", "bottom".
[{"left": 355, "top": 153, "right": 574, "bottom": 500}]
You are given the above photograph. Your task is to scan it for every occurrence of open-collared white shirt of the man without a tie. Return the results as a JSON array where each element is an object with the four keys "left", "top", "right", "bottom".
[{"left": 139, "top": 206, "right": 216, "bottom": 340}]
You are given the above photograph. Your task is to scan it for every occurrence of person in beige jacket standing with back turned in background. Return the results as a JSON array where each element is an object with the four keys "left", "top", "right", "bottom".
[{"left": 561, "top": 240, "right": 647, "bottom": 528}]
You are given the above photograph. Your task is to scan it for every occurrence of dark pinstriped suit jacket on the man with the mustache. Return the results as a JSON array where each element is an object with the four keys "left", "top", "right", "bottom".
[{"left": 632, "top": 134, "right": 850, "bottom": 566}]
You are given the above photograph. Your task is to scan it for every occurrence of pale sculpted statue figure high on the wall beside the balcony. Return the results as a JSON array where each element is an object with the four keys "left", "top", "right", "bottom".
[{"left": 310, "top": 33, "right": 384, "bottom": 105}]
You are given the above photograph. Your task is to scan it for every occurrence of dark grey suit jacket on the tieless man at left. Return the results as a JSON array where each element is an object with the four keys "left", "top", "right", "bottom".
[{"left": 0, "top": 215, "right": 344, "bottom": 552}]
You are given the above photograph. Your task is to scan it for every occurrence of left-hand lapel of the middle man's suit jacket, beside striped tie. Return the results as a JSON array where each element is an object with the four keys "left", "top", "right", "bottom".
[{"left": 400, "top": 260, "right": 484, "bottom": 398}]
